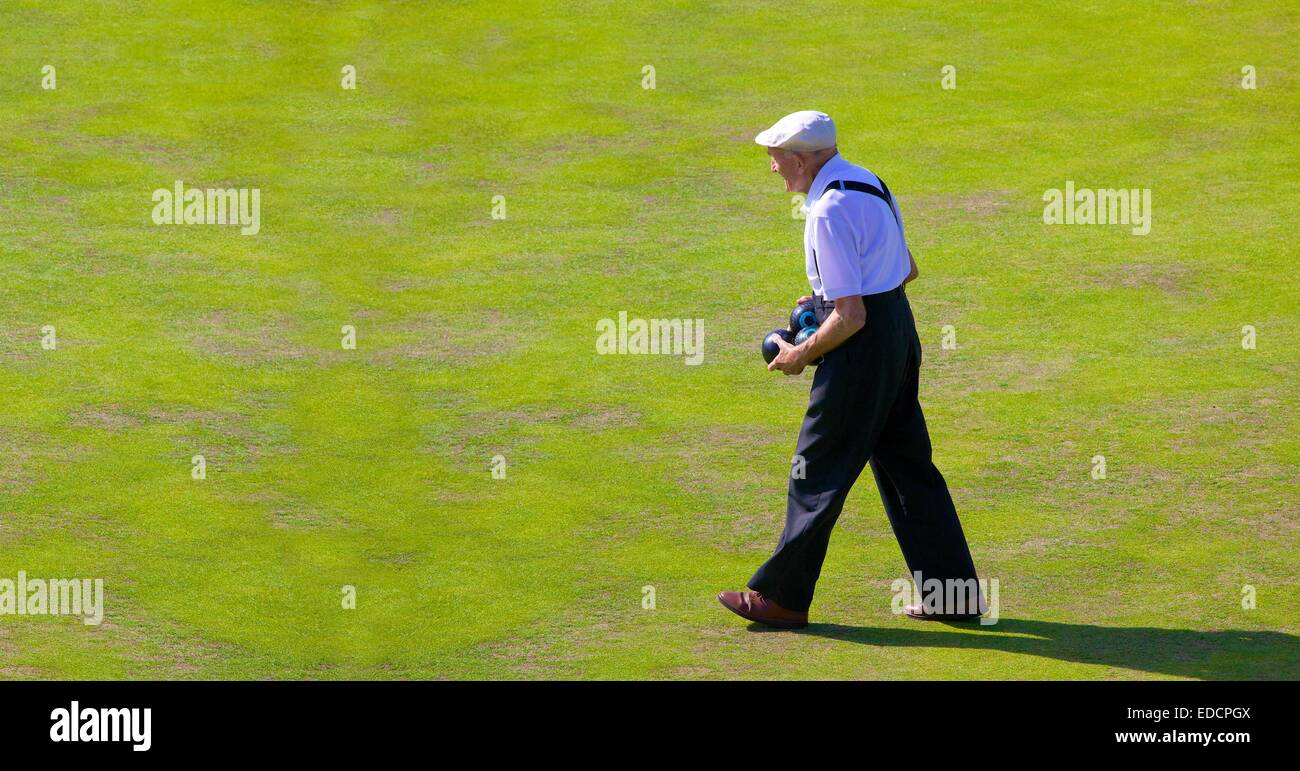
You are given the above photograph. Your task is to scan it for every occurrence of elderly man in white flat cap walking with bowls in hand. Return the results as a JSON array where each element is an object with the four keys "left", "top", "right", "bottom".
[{"left": 718, "top": 111, "right": 984, "bottom": 628}]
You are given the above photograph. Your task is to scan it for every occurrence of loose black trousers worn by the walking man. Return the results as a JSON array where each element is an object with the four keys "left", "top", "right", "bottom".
[{"left": 749, "top": 287, "right": 975, "bottom": 611}]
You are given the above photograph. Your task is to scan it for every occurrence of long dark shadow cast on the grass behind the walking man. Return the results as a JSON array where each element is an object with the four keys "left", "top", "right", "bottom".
[{"left": 749, "top": 619, "right": 1300, "bottom": 680}]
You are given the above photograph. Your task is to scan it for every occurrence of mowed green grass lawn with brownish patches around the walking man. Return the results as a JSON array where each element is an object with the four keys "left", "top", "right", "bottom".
[{"left": 0, "top": 0, "right": 1300, "bottom": 679}]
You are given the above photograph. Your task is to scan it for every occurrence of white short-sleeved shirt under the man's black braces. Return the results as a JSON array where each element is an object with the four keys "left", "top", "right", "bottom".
[{"left": 803, "top": 153, "right": 911, "bottom": 300}]
